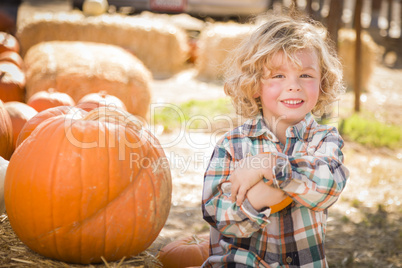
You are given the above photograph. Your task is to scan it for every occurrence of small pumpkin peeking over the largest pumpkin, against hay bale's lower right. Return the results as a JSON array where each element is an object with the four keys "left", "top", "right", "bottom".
[{"left": 77, "top": 91, "right": 127, "bottom": 112}]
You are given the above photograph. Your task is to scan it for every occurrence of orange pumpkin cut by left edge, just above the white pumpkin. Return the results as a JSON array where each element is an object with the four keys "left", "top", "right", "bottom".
[{"left": 0, "top": 100, "right": 13, "bottom": 160}]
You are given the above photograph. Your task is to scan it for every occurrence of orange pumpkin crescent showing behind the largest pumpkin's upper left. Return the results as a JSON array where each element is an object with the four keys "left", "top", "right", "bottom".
[{"left": 16, "top": 106, "right": 87, "bottom": 147}]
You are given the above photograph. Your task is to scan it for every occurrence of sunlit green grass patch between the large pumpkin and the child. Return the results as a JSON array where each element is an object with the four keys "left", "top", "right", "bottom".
[{"left": 151, "top": 98, "right": 234, "bottom": 131}]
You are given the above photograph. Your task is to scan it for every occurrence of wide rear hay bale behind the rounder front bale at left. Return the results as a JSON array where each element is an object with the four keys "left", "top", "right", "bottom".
[{"left": 16, "top": 11, "right": 189, "bottom": 76}]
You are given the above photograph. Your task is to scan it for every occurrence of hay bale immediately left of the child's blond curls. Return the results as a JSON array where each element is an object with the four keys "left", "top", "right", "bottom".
[{"left": 195, "top": 22, "right": 255, "bottom": 80}]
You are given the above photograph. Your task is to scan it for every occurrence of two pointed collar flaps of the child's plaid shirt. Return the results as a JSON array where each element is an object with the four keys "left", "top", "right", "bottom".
[{"left": 242, "top": 113, "right": 317, "bottom": 142}]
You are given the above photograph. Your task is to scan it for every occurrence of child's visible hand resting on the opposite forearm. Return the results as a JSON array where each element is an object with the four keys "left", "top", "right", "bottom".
[{"left": 230, "top": 153, "right": 273, "bottom": 206}]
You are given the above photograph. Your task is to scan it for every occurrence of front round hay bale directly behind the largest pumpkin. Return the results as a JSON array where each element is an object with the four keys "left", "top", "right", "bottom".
[{"left": 24, "top": 41, "right": 151, "bottom": 118}]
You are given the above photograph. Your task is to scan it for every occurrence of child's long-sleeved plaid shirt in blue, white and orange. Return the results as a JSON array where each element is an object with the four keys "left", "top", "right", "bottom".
[{"left": 202, "top": 114, "right": 349, "bottom": 267}]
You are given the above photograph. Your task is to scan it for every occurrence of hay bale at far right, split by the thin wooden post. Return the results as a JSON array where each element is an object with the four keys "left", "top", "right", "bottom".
[{"left": 338, "top": 29, "right": 381, "bottom": 90}]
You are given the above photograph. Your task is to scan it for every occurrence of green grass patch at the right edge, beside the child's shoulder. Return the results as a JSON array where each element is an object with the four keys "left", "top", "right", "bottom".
[{"left": 339, "top": 114, "right": 402, "bottom": 149}]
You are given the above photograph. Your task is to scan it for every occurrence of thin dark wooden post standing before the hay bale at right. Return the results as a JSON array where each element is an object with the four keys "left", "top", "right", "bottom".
[{"left": 354, "top": 0, "right": 363, "bottom": 112}]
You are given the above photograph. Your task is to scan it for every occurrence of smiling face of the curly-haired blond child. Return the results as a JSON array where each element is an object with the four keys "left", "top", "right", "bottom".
[{"left": 257, "top": 49, "right": 321, "bottom": 129}]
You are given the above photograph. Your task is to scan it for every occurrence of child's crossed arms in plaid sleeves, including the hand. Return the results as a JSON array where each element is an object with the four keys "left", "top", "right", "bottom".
[{"left": 202, "top": 130, "right": 348, "bottom": 237}]
